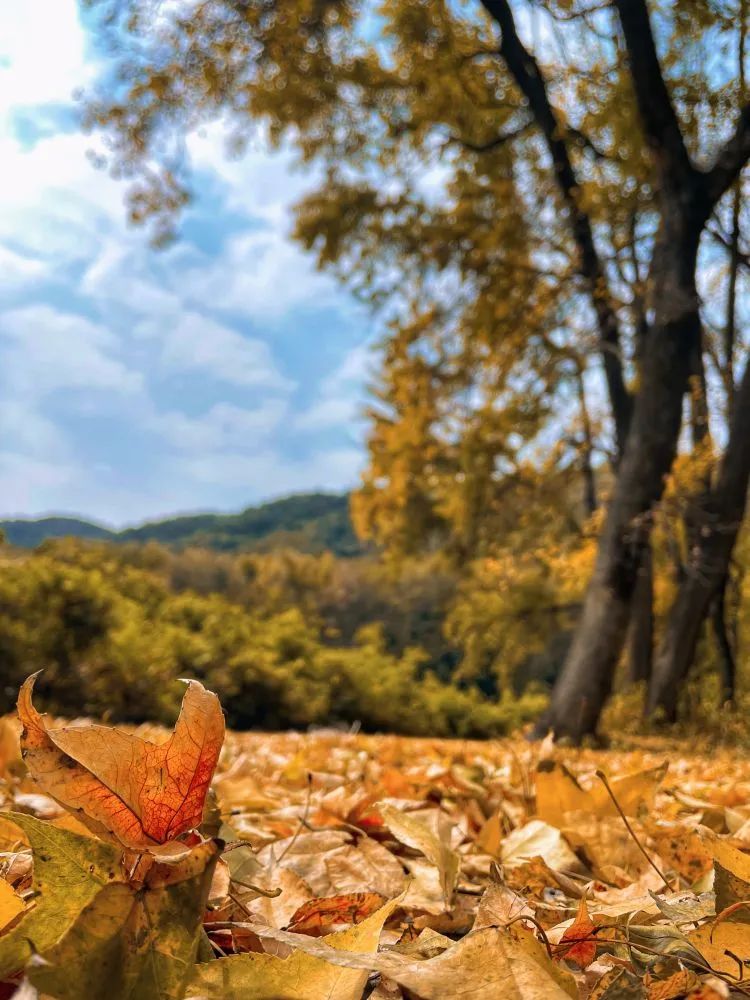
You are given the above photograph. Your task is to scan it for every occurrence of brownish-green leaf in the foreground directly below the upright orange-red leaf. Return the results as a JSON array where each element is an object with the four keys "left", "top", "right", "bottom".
[{"left": 27, "top": 841, "right": 220, "bottom": 1000}]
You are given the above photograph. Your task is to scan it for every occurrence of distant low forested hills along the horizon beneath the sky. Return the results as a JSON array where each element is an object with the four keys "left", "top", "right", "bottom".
[{"left": 0, "top": 493, "right": 363, "bottom": 556}]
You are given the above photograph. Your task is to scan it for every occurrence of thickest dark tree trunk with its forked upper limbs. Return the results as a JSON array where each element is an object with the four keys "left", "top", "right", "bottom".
[{"left": 537, "top": 0, "right": 750, "bottom": 742}]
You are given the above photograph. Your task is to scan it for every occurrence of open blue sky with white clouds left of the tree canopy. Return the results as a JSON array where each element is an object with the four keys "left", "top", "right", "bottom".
[{"left": 0, "top": 0, "right": 374, "bottom": 526}]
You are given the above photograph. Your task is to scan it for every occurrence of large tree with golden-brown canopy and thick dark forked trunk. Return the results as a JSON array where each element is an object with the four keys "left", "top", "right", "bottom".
[{"left": 83, "top": 0, "right": 750, "bottom": 739}]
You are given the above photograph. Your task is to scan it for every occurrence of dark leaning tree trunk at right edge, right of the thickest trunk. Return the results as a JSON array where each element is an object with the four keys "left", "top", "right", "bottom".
[{"left": 647, "top": 362, "right": 750, "bottom": 721}]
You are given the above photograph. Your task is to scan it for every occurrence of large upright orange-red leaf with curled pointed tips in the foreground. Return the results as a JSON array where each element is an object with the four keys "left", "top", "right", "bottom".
[{"left": 18, "top": 674, "right": 224, "bottom": 850}]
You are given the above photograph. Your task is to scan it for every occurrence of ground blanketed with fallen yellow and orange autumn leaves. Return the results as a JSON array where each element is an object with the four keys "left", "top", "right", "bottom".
[{"left": 0, "top": 696, "right": 750, "bottom": 1000}]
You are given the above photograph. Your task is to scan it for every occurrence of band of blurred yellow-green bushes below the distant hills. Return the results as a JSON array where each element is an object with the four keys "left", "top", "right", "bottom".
[{"left": 0, "top": 539, "right": 540, "bottom": 737}]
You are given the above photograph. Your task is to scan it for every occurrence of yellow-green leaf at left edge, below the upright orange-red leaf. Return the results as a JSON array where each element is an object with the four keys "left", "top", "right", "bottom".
[{"left": 0, "top": 813, "right": 124, "bottom": 979}]
